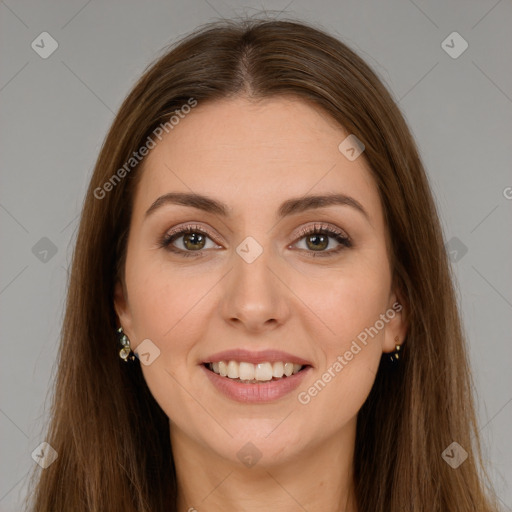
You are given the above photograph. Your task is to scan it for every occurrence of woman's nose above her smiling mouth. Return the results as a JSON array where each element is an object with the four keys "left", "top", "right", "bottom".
[{"left": 222, "top": 242, "right": 290, "bottom": 333}]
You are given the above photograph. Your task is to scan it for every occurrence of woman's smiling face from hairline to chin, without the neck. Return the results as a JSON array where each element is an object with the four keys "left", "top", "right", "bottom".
[{"left": 115, "top": 98, "right": 405, "bottom": 465}]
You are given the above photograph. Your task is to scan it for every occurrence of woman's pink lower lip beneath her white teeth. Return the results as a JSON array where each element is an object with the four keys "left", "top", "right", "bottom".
[{"left": 201, "top": 365, "right": 311, "bottom": 403}]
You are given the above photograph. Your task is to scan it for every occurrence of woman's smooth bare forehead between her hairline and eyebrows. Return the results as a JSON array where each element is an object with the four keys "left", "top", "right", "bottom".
[{"left": 134, "top": 98, "right": 379, "bottom": 224}]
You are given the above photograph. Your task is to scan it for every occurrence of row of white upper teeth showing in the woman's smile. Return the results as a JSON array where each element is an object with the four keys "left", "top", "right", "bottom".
[{"left": 208, "top": 361, "right": 302, "bottom": 382}]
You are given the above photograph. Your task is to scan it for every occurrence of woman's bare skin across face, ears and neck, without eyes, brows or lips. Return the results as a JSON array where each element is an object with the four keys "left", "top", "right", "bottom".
[{"left": 115, "top": 97, "right": 406, "bottom": 512}]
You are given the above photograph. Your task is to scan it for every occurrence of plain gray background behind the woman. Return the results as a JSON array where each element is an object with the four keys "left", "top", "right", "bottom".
[{"left": 0, "top": 0, "right": 512, "bottom": 511}]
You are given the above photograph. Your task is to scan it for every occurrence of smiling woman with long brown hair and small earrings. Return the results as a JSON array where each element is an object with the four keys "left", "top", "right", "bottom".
[{"left": 26, "top": 16, "right": 498, "bottom": 512}]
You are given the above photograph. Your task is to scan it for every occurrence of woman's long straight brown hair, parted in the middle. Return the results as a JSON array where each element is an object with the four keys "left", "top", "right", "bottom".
[{"left": 24, "top": 19, "right": 498, "bottom": 512}]
